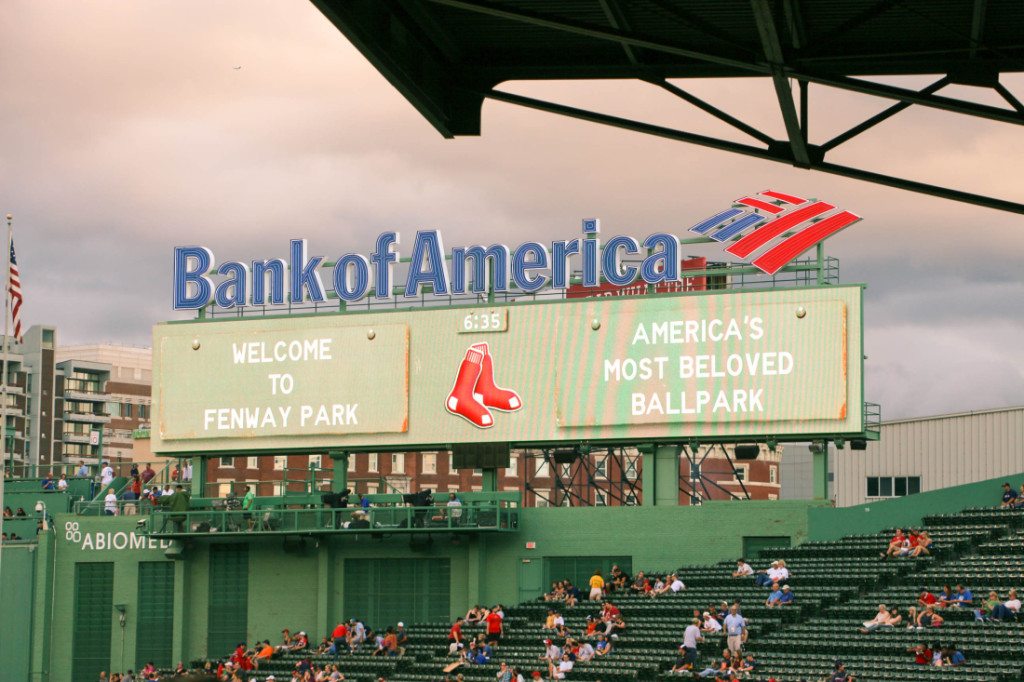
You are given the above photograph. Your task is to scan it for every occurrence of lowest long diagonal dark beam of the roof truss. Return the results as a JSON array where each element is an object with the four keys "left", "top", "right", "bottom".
[{"left": 480, "top": 90, "right": 1024, "bottom": 215}]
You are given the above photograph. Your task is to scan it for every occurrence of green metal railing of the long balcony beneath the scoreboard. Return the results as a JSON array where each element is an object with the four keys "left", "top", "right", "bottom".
[{"left": 137, "top": 501, "right": 519, "bottom": 539}]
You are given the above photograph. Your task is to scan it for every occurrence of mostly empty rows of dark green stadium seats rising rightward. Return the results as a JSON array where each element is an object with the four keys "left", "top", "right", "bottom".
[{"left": 193, "top": 509, "right": 1024, "bottom": 682}]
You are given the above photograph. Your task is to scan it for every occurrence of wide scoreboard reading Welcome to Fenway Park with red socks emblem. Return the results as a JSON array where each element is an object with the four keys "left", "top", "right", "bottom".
[{"left": 153, "top": 286, "right": 863, "bottom": 454}]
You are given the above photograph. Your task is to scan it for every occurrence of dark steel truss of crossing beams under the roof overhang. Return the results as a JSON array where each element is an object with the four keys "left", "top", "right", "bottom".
[{"left": 429, "top": 0, "right": 1024, "bottom": 214}]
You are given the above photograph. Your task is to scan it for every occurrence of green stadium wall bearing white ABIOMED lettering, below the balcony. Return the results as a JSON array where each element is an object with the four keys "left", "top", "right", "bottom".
[{"left": 14, "top": 501, "right": 815, "bottom": 682}]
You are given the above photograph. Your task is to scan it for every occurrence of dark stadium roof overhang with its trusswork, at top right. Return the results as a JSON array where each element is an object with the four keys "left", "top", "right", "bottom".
[{"left": 312, "top": 0, "right": 1024, "bottom": 213}]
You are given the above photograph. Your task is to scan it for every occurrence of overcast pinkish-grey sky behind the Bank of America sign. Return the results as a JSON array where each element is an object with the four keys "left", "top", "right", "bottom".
[{"left": 0, "top": 0, "right": 1024, "bottom": 418}]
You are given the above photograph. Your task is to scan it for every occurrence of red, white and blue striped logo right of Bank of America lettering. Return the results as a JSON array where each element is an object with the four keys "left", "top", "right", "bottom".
[{"left": 690, "top": 189, "right": 860, "bottom": 274}]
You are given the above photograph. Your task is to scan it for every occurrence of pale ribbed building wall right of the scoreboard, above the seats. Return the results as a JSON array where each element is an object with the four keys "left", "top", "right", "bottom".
[{"left": 835, "top": 407, "right": 1024, "bottom": 507}]
